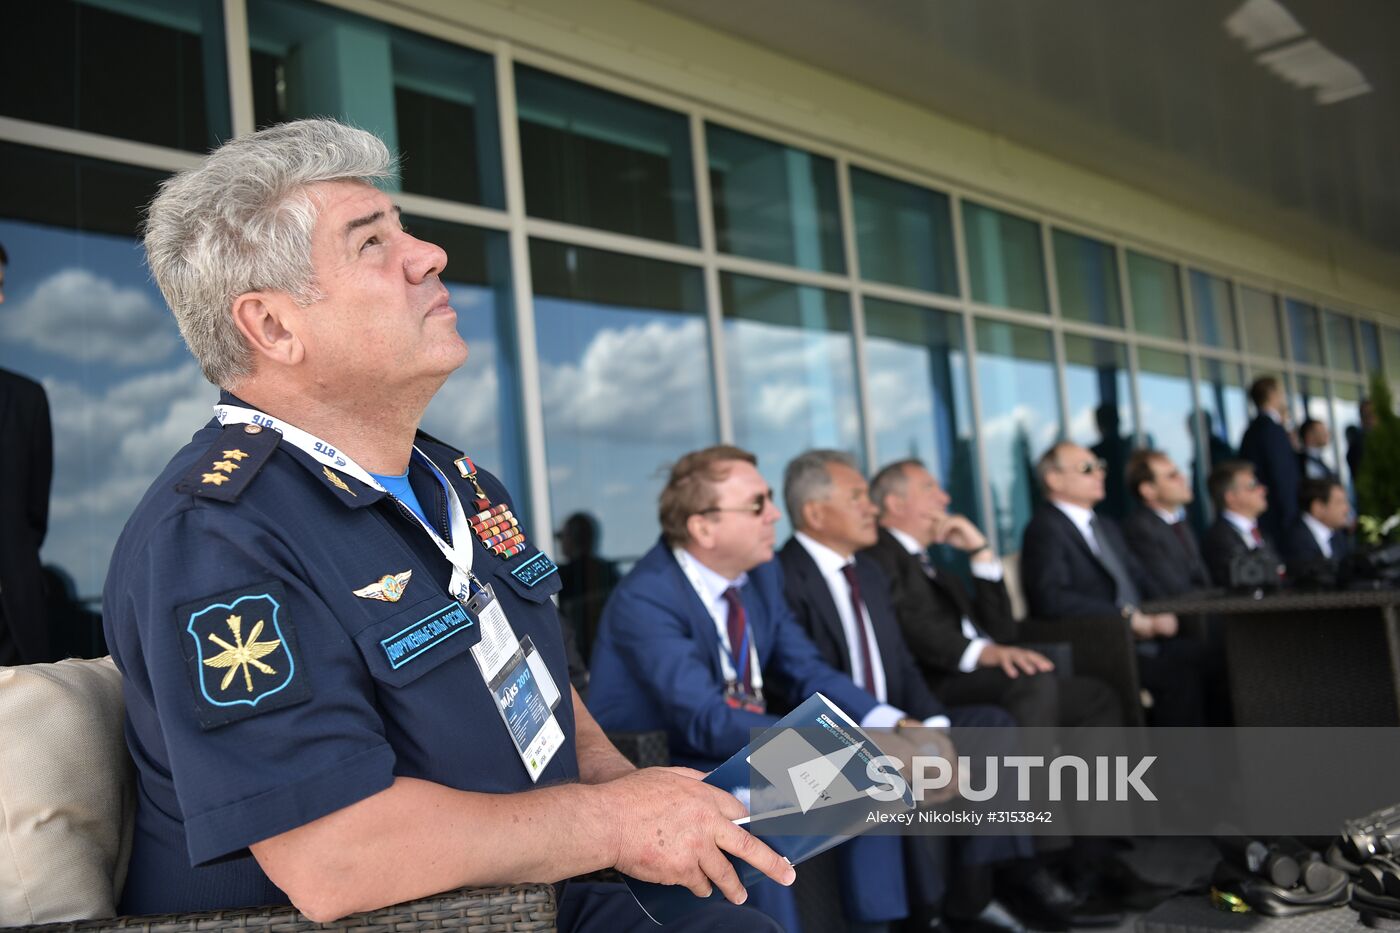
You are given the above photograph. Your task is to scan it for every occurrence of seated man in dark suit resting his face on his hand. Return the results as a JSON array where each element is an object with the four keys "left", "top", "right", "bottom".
[{"left": 861, "top": 459, "right": 1121, "bottom": 727}]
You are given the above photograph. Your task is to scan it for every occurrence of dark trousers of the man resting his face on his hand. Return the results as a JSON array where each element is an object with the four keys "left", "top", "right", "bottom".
[{"left": 935, "top": 667, "right": 1123, "bottom": 728}]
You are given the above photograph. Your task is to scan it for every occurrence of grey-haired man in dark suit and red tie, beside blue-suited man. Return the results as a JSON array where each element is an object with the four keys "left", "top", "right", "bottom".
[{"left": 778, "top": 450, "right": 1082, "bottom": 929}]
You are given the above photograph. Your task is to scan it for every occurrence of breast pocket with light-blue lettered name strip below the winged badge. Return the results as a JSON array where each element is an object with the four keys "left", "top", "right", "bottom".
[{"left": 354, "top": 595, "right": 482, "bottom": 686}]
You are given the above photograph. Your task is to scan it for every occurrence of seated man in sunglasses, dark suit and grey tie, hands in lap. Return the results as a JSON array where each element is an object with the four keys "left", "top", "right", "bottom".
[{"left": 1021, "top": 441, "right": 1205, "bottom": 726}]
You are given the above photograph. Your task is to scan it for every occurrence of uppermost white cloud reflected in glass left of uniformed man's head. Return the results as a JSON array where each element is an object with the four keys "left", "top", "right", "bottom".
[{"left": 0, "top": 269, "right": 179, "bottom": 366}]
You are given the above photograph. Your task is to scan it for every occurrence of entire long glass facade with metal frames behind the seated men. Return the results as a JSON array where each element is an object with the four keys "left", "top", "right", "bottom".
[{"left": 0, "top": 0, "right": 1400, "bottom": 600}]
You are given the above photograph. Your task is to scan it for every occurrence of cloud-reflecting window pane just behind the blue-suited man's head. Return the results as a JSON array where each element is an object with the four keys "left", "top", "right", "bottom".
[{"left": 531, "top": 240, "right": 718, "bottom": 559}]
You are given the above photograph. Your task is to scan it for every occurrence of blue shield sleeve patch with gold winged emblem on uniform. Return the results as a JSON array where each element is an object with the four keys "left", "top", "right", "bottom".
[{"left": 175, "top": 581, "right": 311, "bottom": 728}]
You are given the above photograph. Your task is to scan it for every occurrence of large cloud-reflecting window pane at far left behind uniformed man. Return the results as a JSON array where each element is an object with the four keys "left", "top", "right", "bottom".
[{"left": 0, "top": 144, "right": 204, "bottom": 597}]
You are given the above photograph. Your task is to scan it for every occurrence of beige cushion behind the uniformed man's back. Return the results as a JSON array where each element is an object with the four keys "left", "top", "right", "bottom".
[{"left": 0, "top": 658, "right": 136, "bottom": 927}]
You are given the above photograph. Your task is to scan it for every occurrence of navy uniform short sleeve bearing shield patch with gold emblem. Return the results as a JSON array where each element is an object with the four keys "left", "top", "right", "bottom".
[{"left": 109, "top": 502, "right": 395, "bottom": 864}]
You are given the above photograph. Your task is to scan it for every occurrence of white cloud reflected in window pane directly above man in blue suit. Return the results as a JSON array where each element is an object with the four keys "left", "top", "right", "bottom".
[{"left": 540, "top": 318, "right": 708, "bottom": 443}]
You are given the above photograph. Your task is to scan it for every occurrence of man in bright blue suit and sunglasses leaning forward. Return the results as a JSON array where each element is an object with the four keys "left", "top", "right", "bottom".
[{"left": 588, "top": 445, "right": 884, "bottom": 930}]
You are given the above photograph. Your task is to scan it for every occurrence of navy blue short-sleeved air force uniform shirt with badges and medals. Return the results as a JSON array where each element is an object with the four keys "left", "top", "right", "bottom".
[{"left": 104, "top": 395, "right": 578, "bottom": 913}]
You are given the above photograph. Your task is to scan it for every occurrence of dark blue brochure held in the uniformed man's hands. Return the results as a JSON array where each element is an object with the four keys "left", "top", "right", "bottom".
[{"left": 624, "top": 693, "right": 914, "bottom": 923}]
